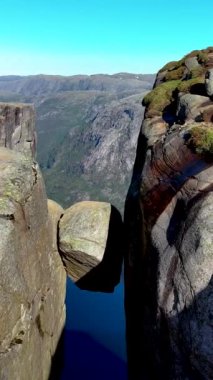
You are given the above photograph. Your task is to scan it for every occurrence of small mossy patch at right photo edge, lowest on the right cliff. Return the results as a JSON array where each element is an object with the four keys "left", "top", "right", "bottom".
[{"left": 187, "top": 124, "right": 213, "bottom": 157}]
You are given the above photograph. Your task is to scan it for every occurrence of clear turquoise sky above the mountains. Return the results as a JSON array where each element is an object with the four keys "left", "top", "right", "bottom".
[{"left": 0, "top": 0, "right": 213, "bottom": 75}]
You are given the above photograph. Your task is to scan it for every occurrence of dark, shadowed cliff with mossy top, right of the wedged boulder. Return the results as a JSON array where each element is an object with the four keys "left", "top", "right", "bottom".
[{"left": 125, "top": 48, "right": 213, "bottom": 380}]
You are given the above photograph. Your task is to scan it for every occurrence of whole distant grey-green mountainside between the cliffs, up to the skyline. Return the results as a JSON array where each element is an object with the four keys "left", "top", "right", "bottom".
[{"left": 0, "top": 73, "right": 155, "bottom": 210}]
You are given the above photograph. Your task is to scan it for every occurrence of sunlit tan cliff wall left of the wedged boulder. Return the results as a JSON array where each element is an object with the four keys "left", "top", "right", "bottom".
[{"left": 0, "top": 104, "right": 66, "bottom": 380}]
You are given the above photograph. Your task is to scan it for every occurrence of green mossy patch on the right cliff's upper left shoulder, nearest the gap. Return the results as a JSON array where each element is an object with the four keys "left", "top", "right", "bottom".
[{"left": 142, "top": 80, "right": 181, "bottom": 115}]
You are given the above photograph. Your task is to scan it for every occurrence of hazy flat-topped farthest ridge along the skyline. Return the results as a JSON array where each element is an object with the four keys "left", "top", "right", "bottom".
[{"left": 0, "top": 73, "right": 153, "bottom": 97}]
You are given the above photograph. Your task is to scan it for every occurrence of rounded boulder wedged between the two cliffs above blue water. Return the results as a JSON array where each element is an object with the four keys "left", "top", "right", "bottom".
[{"left": 59, "top": 201, "right": 123, "bottom": 291}]
